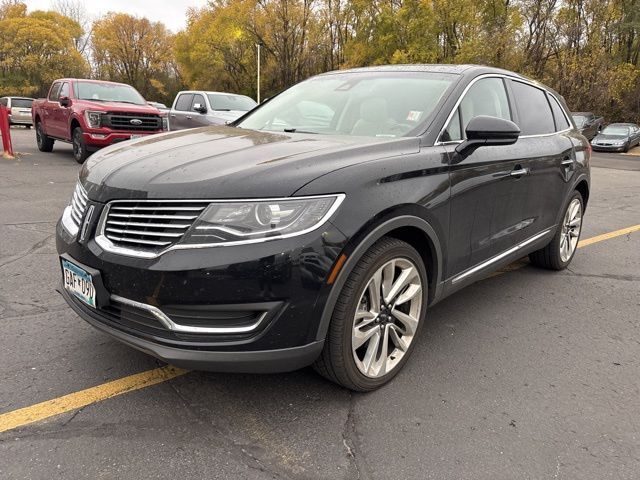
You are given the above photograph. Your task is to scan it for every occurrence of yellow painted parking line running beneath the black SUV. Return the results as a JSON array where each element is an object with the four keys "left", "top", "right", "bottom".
[{"left": 0, "top": 225, "right": 640, "bottom": 433}]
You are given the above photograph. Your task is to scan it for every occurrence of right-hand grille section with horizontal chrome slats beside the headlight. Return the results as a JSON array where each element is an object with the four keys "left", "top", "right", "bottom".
[{"left": 104, "top": 200, "right": 209, "bottom": 251}]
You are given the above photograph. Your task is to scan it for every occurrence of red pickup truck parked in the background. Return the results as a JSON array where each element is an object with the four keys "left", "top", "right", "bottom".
[{"left": 31, "top": 78, "right": 167, "bottom": 163}]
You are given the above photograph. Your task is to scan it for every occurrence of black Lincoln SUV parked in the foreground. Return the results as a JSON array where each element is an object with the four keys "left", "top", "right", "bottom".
[{"left": 57, "top": 65, "right": 590, "bottom": 391}]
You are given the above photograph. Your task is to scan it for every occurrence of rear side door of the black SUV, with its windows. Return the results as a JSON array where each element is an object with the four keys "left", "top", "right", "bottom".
[{"left": 510, "top": 80, "right": 576, "bottom": 240}]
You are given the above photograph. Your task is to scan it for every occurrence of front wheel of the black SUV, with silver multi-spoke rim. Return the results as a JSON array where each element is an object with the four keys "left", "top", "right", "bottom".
[{"left": 314, "top": 237, "right": 428, "bottom": 392}]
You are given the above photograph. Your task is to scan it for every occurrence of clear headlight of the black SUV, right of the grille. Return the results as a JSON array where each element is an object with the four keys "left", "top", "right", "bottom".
[{"left": 180, "top": 194, "right": 345, "bottom": 245}]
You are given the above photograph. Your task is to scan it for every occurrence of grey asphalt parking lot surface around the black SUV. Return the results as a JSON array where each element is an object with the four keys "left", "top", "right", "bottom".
[{"left": 0, "top": 129, "right": 640, "bottom": 479}]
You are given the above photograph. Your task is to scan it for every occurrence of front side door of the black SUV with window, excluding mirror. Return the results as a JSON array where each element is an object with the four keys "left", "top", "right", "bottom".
[{"left": 440, "top": 77, "right": 527, "bottom": 277}]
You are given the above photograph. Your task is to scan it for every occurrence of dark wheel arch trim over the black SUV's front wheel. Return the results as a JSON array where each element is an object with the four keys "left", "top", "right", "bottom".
[{"left": 316, "top": 214, "right": 443, "bottom": 340}]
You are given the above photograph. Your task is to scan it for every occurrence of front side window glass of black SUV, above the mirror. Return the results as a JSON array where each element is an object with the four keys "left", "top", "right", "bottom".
[{"left": 460, "top": 78, "right": 511, "bottom": 132}]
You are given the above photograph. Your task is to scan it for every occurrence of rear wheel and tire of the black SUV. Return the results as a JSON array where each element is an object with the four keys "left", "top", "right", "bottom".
[{"left": 529, "top": 191, "right": 584, "bottom": 270}]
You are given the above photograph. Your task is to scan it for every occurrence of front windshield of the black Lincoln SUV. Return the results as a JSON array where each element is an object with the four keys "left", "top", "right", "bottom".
[{"left": 237, "top": 72, "right": 457, "bottom": 138}]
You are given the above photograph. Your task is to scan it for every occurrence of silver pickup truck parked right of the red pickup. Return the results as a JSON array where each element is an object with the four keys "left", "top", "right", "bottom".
[{"left": 169, "top": 91, "right": 257, "bottom": 130}]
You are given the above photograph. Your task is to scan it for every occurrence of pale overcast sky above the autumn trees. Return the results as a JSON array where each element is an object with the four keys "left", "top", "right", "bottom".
[{"left": 23, "top": 0, "right": 207, "bottom": 32}]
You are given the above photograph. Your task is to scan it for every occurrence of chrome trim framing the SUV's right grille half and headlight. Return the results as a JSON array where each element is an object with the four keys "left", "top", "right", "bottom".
[{"left": 95, "top": 193, "right": 346, "bottom": 259}]
